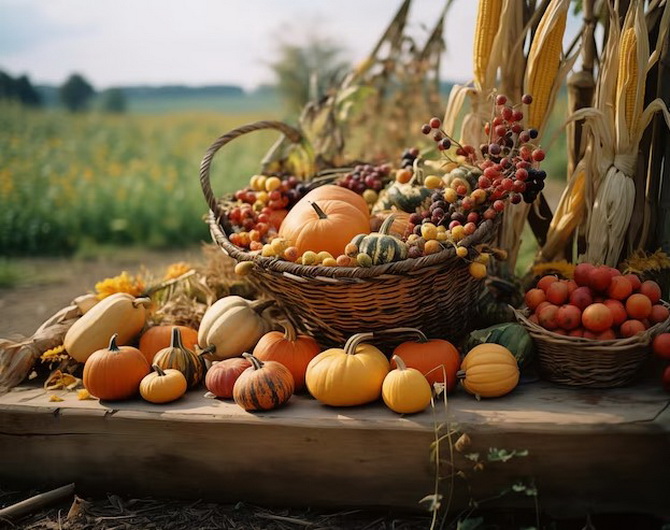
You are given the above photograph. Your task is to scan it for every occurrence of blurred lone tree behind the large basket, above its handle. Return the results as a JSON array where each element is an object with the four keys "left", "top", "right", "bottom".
[{"left": 270, "top": 37, "right": 349, "bottom": 112}]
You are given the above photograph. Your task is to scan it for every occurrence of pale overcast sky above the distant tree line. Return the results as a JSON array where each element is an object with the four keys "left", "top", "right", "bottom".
[{"left": 0, "top": 0, "right": 584, "bottom": 89}]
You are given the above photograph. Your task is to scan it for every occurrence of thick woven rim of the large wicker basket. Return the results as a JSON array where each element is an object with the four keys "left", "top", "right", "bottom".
[{"left": 207, "top": 210, "right": 496, "bottom": 281}]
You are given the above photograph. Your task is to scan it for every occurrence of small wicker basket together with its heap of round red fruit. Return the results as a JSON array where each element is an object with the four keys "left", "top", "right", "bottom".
[{"left": 515, "top": 263, "right": 670, "bottom": 388}]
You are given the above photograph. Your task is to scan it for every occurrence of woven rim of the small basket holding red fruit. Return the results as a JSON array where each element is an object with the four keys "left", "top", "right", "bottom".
[{"left": 510, "top": 300, "right": 670, "bottom": 354}]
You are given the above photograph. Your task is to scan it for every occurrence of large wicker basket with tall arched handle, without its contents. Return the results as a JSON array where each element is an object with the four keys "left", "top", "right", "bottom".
[{"left": 200, "top": 121, "right": 496, "bottom": 346}]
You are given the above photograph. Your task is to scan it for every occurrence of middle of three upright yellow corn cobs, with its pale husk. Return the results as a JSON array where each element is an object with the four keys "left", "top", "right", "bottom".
[{"left": 525, "top": 0, "right": 569, "bottom": 129}]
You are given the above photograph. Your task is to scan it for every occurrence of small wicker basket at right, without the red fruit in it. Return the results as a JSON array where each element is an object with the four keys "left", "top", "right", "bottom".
[{"left": 514, "top": 302, "right": 670, "bottom": 388}]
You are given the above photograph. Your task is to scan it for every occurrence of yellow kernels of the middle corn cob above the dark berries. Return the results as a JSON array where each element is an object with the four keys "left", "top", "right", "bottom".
[{"left": 526, "top": 11, "right": 568, "bottom": 129}]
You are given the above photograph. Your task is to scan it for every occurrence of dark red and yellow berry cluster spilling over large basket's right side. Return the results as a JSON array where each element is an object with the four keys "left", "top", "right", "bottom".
[{"left": 421, "top": 94, "right": 546, "bottom": 218}]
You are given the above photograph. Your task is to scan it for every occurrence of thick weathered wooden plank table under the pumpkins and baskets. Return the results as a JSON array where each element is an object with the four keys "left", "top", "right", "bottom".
[{"left": 0, "top": 376, "right": 670, "bottom": 516}]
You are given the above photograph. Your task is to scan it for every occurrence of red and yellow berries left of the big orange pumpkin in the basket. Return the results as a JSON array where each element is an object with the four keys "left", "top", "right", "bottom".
[{"left": 228, "top": 175, "right": 308, "bottom": 250}]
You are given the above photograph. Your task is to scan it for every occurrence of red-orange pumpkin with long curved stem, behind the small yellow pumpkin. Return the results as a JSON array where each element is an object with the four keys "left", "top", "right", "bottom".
[{"left": 388, "top": 328, "right": 461, "bottom": 392}]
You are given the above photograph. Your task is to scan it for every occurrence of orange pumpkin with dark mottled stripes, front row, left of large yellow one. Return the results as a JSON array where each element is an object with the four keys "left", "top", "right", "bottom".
[{"left": 233, "top": 353, "right": 295, "bottom": 412}]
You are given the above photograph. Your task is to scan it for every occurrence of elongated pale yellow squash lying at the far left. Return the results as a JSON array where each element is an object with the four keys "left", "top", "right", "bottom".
[{"left": 63, "top": 293, "right": 151, "bottom": 363}]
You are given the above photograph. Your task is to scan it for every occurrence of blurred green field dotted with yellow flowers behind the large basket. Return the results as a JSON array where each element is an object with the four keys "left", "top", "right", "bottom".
[{"left": 0, "top": 107, "right": 275, "bottom": 256}]
